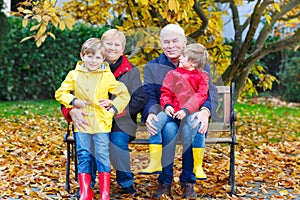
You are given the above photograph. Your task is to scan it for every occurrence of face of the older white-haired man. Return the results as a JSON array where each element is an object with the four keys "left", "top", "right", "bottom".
[{"left": 160, "top": 31, "right": 186, "bottom": 60}]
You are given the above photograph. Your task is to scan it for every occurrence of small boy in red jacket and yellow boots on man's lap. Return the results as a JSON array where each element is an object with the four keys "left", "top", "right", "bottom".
[{"left": 140, "top": 44, "right": 209, "bottom": 180}]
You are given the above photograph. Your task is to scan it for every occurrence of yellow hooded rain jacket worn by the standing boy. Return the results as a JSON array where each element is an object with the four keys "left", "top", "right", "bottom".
[{"left": 55, "top": 61, "right": 130, "bottom": 134}]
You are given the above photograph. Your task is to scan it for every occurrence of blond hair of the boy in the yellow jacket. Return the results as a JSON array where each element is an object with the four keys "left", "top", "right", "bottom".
[{"left": 80, "top": 38, "right": 105, "bottom": 58}]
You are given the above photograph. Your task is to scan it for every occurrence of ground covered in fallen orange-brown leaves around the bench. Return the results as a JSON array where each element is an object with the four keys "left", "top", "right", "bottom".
[{"left": 0, "top": 99, "right": 300, "bottom": 199}]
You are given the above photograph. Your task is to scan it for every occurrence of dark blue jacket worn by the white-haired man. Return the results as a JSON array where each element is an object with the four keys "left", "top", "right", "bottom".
[{"left": 142, "top": 53, "right": 218, "bottom": 121}]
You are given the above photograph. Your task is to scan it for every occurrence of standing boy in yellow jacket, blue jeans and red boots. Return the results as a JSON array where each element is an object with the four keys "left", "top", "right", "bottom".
[{"left": 55, "top": 38, "right": 130, "bottom": 199}]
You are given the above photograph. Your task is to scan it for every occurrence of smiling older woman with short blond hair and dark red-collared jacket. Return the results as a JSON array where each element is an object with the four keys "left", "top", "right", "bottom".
[{"left": 62, "top": 29, "right": 146, "bottom": 194}]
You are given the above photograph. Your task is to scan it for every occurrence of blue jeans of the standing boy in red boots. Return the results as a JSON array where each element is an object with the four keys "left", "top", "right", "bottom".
[{"left": 76, "top": 132, "right": 110, "bottom": 174}]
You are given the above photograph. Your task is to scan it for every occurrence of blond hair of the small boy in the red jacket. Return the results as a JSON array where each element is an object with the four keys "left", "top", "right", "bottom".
[{"left": 183, "top": 43, "right": 209, "bottom": 69}]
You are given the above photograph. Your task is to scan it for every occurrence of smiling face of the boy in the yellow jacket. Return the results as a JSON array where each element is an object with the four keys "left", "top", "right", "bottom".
[{"left": 81, "top": 50, "right": 104, "bottom": 71}]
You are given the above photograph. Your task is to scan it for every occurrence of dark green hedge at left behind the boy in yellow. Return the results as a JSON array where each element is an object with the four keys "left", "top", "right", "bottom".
[{"left": 0, "top": 17, "right": 107, "bottom": 100}]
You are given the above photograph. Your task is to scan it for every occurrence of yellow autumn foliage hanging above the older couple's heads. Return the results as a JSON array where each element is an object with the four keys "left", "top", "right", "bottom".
[{"left": 13, "top": 0, "right": 234, "bottom": 84}]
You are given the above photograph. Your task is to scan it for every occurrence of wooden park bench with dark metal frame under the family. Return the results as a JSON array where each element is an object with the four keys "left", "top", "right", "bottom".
[{"left": 64, "top": 83, "right": 237, "bottom": 194}]
